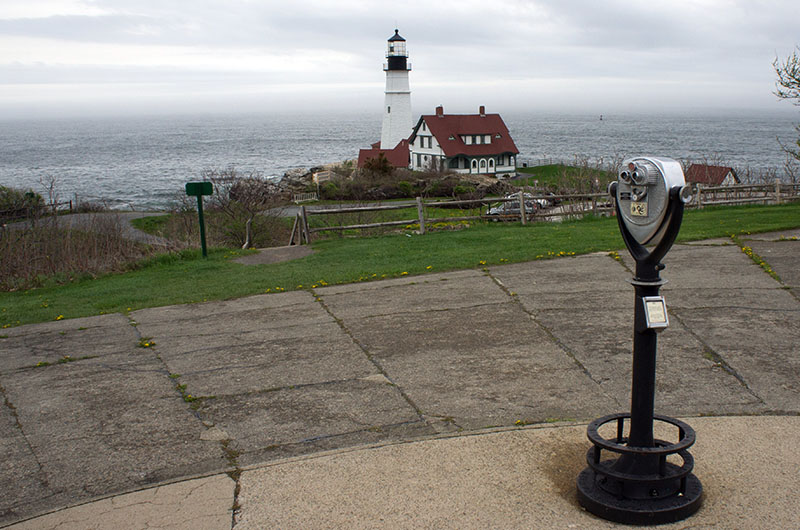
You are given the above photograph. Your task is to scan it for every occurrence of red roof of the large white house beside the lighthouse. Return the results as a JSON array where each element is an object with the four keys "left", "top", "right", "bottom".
[{"left": 409, "top": 109, "right": 519, "bottom": 157}]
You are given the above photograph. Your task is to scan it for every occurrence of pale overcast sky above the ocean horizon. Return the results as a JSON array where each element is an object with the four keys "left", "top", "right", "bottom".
[{"left": 0, "top": 0, "right": 800, "bottom": 118}]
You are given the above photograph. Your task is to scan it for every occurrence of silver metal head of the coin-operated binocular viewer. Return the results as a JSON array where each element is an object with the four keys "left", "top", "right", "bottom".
[{"left": 609, "top": 157, "right": 692, "bottom": 245}]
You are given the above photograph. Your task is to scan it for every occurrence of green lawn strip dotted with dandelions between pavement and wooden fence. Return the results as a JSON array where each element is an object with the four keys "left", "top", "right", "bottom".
[{"left": 0, "top": 203, "right": 800, "bottom": 327}]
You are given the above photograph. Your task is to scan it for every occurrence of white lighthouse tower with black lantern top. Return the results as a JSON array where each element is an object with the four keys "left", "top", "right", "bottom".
[{"left": 381, "top": 30, "right": 414, "bottom": 149}]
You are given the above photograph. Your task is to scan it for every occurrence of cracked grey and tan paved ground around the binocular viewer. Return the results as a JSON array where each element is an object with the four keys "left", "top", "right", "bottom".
[{"left": 0, "top": 231, "right": 800, "bottom": 529}]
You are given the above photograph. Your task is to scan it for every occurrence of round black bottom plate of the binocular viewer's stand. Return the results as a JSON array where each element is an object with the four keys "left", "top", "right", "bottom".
[{"left": 578, "top": 468, "right": 703, "bottom": 525}]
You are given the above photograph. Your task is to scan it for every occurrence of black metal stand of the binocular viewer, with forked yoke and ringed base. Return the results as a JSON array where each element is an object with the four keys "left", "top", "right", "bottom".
[{"left": 578, "top": 184, "right": 703, "bottom": 524}]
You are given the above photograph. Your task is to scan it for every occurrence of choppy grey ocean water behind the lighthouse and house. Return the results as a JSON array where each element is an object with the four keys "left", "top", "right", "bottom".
[{"left": 0, "top": 112, "right": 800, "bottom": 210}]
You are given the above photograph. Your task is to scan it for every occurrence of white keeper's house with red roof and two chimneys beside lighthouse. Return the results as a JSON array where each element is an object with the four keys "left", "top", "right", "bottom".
[{"left": 408, "top": 106, "right": 519, "bottom": 177}]
